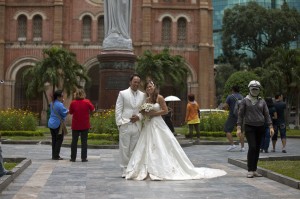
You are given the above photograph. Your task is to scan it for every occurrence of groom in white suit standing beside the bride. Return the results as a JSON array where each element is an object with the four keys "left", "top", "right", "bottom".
[{"left": 116, "top": 74, "right": 146, "bottom": 178}]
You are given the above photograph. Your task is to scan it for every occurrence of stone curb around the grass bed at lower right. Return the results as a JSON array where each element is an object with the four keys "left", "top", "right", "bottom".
[{"left": 228, "top": 156, "right": 300, "bottom": 189}]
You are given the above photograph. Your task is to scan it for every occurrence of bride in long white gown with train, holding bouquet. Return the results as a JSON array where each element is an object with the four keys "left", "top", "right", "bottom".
[{"left": 126, "top": 81, "right": 226, "bottom": 180}]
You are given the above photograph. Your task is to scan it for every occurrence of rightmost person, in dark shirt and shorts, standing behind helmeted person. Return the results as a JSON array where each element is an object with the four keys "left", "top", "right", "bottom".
[{"left": 272, "top": 93, "right": 286, "bottom": 153}]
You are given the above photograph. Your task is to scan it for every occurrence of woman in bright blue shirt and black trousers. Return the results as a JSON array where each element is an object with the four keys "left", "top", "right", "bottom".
[{"left": 48, "top": 90, "right": 68, "bottom": 160}]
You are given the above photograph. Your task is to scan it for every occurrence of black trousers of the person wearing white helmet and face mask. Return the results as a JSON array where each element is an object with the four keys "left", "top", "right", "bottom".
[{"left": 245, "top": 125, "right": 265, "bottom": 171}]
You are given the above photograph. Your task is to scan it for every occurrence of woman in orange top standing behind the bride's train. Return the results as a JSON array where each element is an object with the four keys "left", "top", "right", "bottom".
[{"left": 185, "top": 94, "right": 200, "bottom": 141}]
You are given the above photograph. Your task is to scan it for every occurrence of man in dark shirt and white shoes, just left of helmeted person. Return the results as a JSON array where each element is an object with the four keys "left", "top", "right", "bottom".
[{"left": 224, "top": 85, "right": 245, "bottom": 152}]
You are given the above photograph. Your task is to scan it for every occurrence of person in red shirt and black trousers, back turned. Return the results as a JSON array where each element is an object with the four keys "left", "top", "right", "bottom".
[{"left": 69, "top": 89, "right": 95, "bottom": 162}]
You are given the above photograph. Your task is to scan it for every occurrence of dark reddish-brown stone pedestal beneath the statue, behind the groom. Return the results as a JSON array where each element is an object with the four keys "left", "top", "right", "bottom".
[{"left": 98, "top": 50, "right": 136, "bottom": 109}]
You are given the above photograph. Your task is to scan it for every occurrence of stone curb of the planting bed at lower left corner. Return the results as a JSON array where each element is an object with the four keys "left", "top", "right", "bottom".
[{"left": 0, "top": 158, "right": 31, "bottom": 193}]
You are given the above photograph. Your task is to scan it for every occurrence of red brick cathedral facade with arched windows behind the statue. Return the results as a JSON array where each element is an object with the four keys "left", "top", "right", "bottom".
[{"left": 0, "top": 0, "right": 216, "bottom": 125}]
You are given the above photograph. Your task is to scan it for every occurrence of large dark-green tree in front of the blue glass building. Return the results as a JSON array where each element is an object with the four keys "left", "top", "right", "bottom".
[{"left": 222, "top": 1, "right": 300, "bottom": 69}]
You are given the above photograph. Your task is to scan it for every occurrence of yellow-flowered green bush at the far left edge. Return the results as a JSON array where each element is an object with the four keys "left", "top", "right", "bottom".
[{"left": 0, "top": 109, "right": 38, "bottom": 131}]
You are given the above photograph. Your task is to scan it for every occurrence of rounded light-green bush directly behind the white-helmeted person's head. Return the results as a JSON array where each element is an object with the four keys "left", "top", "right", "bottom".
[{"left": 223, "top": 71, "right": 260, "bottom": 101}]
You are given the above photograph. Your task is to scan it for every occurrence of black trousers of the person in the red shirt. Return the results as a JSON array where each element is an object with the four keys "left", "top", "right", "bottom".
[{"left": 71, "top": 129, "right": 89, "bottom": 160}]
